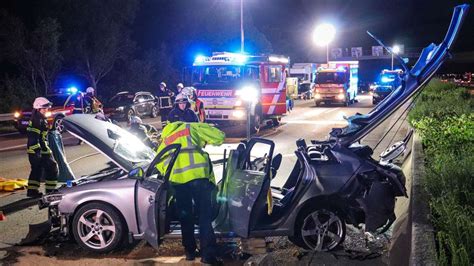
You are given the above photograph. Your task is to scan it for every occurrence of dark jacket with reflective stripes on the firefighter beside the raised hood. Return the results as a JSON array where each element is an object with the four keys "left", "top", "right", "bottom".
[{"left": 26, "top": 110, "right": 51, "bottom": 154}]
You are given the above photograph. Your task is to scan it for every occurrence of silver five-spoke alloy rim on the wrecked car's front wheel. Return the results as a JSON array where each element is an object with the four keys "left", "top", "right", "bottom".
[{"left": 76, "top": 209, "right": 117, "bottom": 250}]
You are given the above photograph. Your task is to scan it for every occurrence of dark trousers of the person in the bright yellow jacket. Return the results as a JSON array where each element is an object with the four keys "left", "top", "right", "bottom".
[{"left": 173, "top": 179, "right": 216, "bottom": 259}]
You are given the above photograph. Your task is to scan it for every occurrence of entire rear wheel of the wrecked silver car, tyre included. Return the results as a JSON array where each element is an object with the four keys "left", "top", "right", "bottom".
[{"left": 290, "top": 207, "right": 346, "bottom": 251}]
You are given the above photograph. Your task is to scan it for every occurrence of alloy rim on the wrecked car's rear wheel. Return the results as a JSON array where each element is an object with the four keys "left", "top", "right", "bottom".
[{"left": 300, "top": 209, "right": 345, "bottom": 251}]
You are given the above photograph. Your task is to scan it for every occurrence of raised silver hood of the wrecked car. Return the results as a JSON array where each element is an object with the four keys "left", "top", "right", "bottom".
[{"left": 63, "top": 114, "right": 155, "bottom": 172}]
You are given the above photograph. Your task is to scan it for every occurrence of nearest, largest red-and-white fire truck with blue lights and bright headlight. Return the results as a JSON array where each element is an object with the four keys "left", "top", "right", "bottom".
[{"left": 192, "top": 52, "right": 289, "bottom": 130}]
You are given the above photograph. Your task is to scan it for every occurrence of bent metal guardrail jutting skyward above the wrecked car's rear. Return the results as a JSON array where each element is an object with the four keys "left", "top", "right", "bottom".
[{"left": 330, "top": 5, "right": 469, "bottom": 146}]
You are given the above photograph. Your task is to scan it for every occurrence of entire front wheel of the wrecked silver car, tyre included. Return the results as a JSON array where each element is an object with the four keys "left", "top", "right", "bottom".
[{"left": 72, "top": 203, "right": 125, "bottom": 253}]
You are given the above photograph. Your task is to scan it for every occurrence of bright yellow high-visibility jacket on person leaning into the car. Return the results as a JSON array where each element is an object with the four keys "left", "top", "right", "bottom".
[{"left": 157, "top": 121, "right": 225, "bottom": 184}]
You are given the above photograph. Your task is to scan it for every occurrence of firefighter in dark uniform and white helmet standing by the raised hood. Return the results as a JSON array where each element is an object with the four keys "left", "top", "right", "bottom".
[{"left": 26, "top": 97, "right": 58, "bottom": 198}]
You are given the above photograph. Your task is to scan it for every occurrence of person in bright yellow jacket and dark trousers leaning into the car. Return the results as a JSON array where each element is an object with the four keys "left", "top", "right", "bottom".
[{"left": 156, "top": 122, "right": 225, "bottom": 264}]
